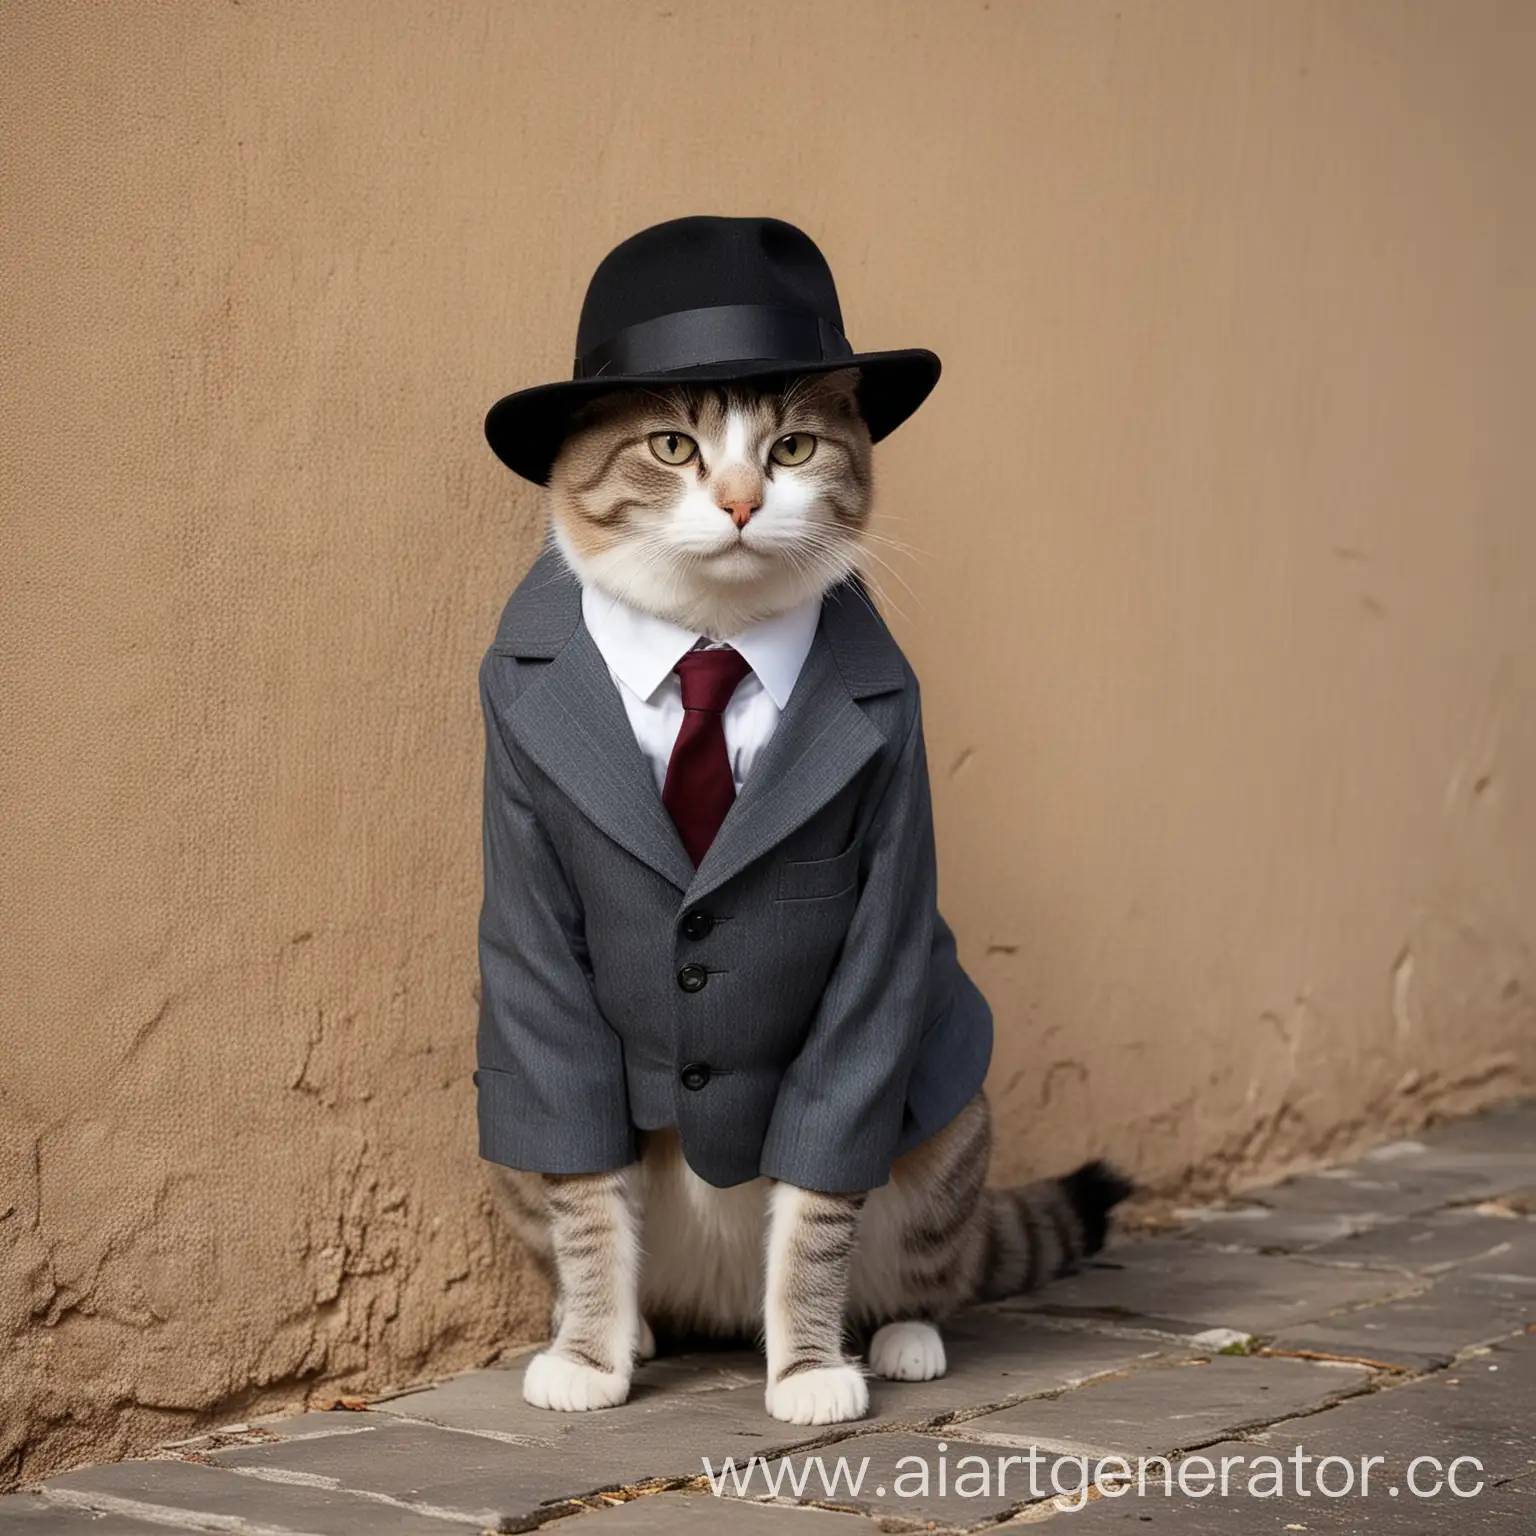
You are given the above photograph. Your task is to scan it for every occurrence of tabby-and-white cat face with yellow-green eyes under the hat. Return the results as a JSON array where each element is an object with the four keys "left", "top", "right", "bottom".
[{"left": 550, "top": 369, "right": 871, "bottom": 637}]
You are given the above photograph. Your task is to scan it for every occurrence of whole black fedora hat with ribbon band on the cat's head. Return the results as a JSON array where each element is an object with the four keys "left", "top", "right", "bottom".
[{"left": 485, "top": 218, "right": 938, "bottom": 485}]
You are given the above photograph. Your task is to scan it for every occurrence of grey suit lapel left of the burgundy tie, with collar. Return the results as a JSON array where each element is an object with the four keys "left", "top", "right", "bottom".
[{"left": 496, "top": 554, "right": 694, "bottom": 891}]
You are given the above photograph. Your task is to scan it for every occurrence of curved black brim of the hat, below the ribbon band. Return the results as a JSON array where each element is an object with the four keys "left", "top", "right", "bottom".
[{"left": 485, "top": 347, "right": 940, "bottom": 485}]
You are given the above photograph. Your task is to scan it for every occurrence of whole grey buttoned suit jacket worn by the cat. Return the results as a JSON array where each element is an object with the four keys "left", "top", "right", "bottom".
[{"left": 475, "top": 551, "right": 992, "bottom": 1190}]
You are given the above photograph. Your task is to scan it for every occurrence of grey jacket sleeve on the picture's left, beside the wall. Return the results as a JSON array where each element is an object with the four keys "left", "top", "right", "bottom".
[{"left": 475, "top": 656, "right": 634, "bottom": 1174}]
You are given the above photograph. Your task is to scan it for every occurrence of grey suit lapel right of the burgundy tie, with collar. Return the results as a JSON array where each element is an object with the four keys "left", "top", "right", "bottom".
[{"left": 688, "top": 584, "right": 906, "bottom": 902}]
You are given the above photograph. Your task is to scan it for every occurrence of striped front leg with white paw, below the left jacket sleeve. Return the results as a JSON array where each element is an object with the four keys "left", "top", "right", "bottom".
[{"left": 522, "top": 1169, "right": 641, "bottom": 1412}]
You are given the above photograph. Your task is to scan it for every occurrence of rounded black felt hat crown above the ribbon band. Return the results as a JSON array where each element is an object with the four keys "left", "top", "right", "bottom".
[{"left": 576, "top": 215, "right": 843, "bottom": 358}]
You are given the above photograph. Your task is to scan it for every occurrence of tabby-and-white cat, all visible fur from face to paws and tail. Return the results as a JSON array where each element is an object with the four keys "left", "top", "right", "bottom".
[{"left": 495, "top": 369, "right": 1130, "bottom": 1424}]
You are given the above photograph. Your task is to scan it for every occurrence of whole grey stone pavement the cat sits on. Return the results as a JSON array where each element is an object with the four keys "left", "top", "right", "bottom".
[{"left": 0, "top": 1104, "right": 1536, "bottom": 1536}]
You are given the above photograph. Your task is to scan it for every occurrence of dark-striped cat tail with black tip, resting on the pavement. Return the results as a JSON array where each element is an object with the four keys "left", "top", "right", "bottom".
[{"left": 982, "top": 1160, "right": 1132, "bottom": 1301}]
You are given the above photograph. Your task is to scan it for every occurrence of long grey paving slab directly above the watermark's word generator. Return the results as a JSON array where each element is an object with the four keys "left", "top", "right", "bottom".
[{"left": 965, "top": 1355, "right": 1372, "bottom": 1458}]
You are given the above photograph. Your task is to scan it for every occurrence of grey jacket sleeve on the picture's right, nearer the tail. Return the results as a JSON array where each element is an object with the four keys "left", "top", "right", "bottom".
[{"left": 760, "top": 691, "right": 937, "bottom": 1190}]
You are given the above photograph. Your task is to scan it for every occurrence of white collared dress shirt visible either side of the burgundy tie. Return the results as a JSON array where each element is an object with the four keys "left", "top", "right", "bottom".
[{"left": 581, "top": 585, "right": 822, "bottom": 794}]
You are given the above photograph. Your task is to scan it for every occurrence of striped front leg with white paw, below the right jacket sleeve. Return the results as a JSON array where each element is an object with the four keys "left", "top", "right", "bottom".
[{"left": 763, "top": 1184, "right": 869, "bottom": 1424}]
